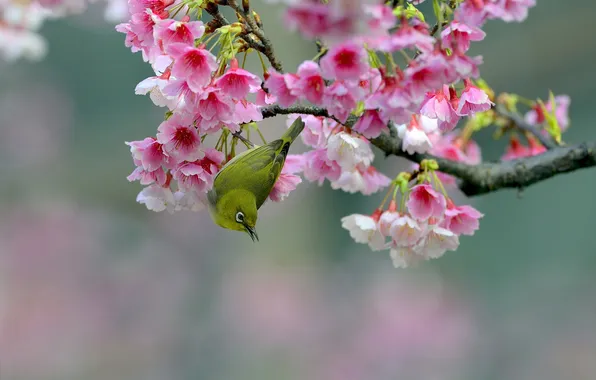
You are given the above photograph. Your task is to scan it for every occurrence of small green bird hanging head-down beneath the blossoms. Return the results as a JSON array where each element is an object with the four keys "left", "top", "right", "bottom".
[{"left": 207, "top": 118, "right": 304, "bottom": 241}]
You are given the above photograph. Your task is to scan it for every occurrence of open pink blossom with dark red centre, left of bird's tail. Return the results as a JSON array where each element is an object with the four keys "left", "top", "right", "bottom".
[{"left": 157, "top": 114, "right": 205, "bottom": 161}]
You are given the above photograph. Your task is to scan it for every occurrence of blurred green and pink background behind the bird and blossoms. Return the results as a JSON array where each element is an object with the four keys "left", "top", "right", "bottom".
[{"left": 0, "top": 0, "right": 596, "bottom": 380}]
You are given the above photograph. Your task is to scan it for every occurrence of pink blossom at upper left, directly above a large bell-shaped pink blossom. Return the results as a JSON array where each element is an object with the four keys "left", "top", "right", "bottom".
[{"left": 153, "top": 17, "right": 205, "bottom": 49}]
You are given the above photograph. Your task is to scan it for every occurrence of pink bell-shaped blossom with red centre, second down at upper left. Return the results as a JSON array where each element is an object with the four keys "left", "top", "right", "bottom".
[{"left": 166, "top": 43, "right": 217, "bottom": 93}]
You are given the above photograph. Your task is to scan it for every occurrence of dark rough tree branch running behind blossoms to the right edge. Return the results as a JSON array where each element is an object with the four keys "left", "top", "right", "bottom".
[{"left": 261, "top": 105, "right": 596, "bottom": 196}]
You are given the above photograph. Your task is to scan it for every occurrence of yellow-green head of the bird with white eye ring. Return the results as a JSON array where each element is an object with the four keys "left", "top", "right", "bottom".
[{"left": 211, "top": 190, "right": 259, "bottom": 241}]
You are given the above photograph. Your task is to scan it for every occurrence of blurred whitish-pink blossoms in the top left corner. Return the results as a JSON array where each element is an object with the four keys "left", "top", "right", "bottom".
[{"left": 0, "top": 0, "right": 126, "bottom": 62}]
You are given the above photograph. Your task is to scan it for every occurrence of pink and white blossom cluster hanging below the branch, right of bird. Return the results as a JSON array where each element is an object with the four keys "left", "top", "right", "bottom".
[{"left": 342, "top": 162, "right": 483, "bottom": 268}]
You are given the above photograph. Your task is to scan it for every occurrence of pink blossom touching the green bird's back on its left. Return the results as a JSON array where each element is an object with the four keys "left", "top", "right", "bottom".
[{"left": 173, "top": 148, "right": 224, "bottom": 193}]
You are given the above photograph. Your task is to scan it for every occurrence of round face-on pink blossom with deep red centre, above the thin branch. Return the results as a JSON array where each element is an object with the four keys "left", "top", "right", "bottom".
[{"left": 321, "top": 42, "right": 368, "bottom": 80}]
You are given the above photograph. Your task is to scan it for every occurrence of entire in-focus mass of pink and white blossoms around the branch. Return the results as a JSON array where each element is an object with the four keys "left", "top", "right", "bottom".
[{"left": 116, "top": 0, "right": 569, "bottom": 267}]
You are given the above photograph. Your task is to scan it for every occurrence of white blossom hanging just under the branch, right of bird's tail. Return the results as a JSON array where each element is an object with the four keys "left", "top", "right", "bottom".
[{"left": 327, "top": 132, "right": 374, "bottom": 170}]
